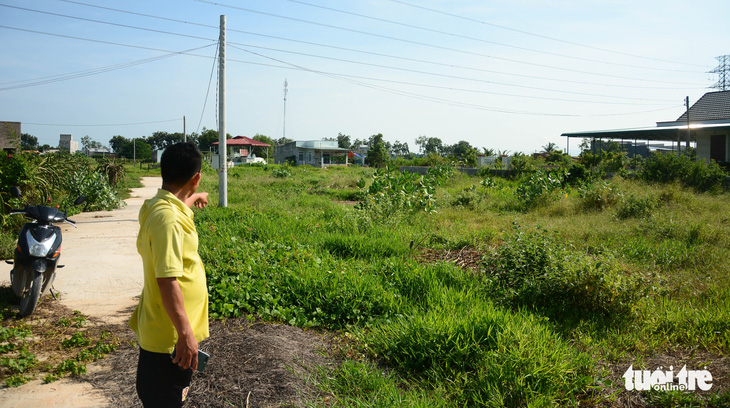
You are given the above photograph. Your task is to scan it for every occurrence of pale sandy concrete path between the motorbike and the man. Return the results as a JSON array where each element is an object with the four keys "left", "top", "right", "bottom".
[{"left": 0, "top": 177, "right": 162, "bottom": 408}]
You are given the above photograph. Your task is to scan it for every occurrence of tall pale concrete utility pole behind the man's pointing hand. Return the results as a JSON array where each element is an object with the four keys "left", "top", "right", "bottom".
[{"left": 218, "top": 15, "right": 228, "bottom": 208}]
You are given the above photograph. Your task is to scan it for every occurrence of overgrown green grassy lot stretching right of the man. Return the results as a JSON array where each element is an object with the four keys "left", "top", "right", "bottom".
[{"left": 196, "top": 166, "right": 730, "bottom": 407}]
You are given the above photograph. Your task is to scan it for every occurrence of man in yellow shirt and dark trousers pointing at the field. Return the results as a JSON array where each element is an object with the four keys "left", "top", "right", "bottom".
[{"left": 129, "top": 143, "right": 209, "bottom": 407}]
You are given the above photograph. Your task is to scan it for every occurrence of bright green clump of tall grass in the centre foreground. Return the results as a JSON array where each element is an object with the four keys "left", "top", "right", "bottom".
[{"left": 358, "top": 289, "right": 591, "bottom": 407}]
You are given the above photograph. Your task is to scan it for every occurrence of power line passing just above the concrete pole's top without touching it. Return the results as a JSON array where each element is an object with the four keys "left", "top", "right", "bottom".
[{"left": 195, "top": 0, "right": 700, "bottom": 81}]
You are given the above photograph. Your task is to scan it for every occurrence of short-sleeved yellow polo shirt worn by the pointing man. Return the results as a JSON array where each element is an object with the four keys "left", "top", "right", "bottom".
[{"left": 129, "top": 189, "right": 209, "bottom": 353}]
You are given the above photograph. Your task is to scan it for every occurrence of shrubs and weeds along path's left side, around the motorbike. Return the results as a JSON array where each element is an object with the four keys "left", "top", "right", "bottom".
[{"left": 0, "top": 153, "right": 136, "bottom": 387}]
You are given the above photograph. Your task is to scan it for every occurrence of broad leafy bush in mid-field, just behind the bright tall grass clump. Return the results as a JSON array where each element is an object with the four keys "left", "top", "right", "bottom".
[{"left": 484, "top": 227, "right": 646, "bottom": 320}]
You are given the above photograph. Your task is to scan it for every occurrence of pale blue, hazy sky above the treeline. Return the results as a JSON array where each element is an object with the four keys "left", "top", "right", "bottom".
[{"left": 0, "top": 0, "right": 730, "bottom": 155}]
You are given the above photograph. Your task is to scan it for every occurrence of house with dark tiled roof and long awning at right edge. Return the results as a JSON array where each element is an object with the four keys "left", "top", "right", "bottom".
[{"left": 562, "top": 91, "right": 730, "bottom": 162}]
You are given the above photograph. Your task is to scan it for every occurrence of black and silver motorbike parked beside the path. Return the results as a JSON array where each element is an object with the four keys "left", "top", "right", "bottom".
[{"left": 6, "top": 187, "right": 86, "bottom": 317}]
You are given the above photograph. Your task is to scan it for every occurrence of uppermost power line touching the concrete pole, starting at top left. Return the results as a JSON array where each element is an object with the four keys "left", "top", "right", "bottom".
[{"left": 55, "top": 0, "right": 704, "bottom": 89}]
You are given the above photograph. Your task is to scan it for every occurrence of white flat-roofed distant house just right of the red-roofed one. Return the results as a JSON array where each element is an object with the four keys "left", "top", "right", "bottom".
[{"left": 274, "top": 140, "right": 351, "bottom": 167}]
